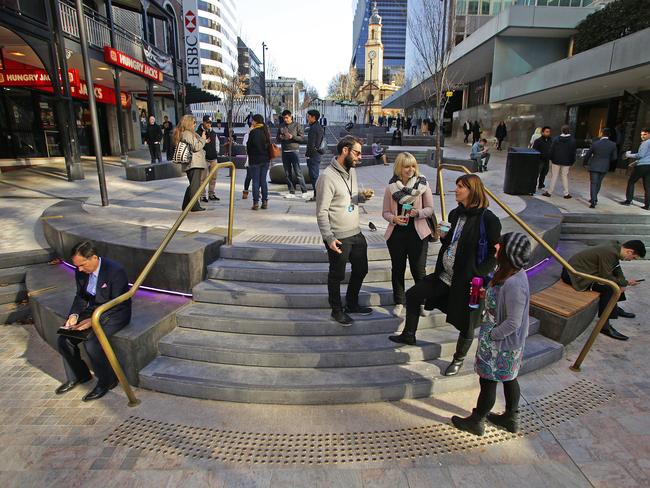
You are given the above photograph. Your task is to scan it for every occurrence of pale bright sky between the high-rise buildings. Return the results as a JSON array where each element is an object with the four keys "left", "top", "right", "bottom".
[{"left": 237, "top": 0, "right": 354, "bottom": 97}]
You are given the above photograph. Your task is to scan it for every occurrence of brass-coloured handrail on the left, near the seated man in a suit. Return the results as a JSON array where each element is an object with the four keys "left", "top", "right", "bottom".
[{"left": 91, "top": 161, "right": 236, "bottom": 407}]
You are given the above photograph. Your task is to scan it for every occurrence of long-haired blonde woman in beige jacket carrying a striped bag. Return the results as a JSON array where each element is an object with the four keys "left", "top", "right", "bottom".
[{"left": 173, "top": 115, "right": 207, "bottom": 212}]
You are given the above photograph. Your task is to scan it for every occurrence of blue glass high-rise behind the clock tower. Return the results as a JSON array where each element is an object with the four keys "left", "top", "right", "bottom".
[{"left": 351, "top": 0, "right": 407, "bottom": 83}]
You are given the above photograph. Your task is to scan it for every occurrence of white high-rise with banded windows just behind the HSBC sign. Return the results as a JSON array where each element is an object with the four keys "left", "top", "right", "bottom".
[{"left": 195, "top": 0, "right": 239, "bottom": 93}]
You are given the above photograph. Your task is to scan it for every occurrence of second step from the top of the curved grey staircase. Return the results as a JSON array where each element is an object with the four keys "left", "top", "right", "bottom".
[{"left": 208, "top": 256, "right": 437, "bottom": 284}]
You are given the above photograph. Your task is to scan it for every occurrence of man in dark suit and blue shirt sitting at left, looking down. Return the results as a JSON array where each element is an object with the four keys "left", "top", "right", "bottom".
[{"left": 56, "top": 241, "right": 131, "bottom": 402}]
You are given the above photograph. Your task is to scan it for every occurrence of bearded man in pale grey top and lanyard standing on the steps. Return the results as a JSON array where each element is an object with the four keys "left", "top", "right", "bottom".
[{"left": 316, "top": 136, "right": 374, "bottom": 326}]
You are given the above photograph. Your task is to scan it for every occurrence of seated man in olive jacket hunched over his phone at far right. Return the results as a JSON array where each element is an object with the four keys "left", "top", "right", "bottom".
[{"left": 562, "top": 240, "right": 645, "bottom": 341}]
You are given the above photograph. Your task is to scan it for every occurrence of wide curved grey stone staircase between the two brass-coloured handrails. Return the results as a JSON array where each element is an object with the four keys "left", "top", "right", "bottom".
[{"left": 139, "top": 233, "right": 562, "bottom": 404}]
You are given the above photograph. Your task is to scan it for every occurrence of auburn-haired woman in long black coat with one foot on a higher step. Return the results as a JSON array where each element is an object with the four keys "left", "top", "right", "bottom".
[{"left": 389, "top": 174, "right": 501, "bottom": 376}]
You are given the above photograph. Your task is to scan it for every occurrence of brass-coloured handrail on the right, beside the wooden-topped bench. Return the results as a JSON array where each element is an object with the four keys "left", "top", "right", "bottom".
[{"left": 437, "top": 164, "right": 621, "bottom": 371}]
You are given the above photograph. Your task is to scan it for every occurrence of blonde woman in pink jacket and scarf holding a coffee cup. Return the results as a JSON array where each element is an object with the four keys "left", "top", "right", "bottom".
[{"left": 383, "top": 152, "right": 433, "bottom": 317}]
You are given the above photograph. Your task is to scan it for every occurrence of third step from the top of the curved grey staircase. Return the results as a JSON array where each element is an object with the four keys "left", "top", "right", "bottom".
[{"left": 192, "top": 280, "right": 400, "bottom": 308}]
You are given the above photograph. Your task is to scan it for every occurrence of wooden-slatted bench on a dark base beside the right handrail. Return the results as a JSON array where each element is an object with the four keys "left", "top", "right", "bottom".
[{"left": 530, "top": 280, "right": 600, "bottom": 345}]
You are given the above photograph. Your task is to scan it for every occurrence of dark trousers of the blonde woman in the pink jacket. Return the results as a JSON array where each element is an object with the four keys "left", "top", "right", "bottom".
[{"left": 386, "top": 225, "right": 429, "bottom": 305}]
